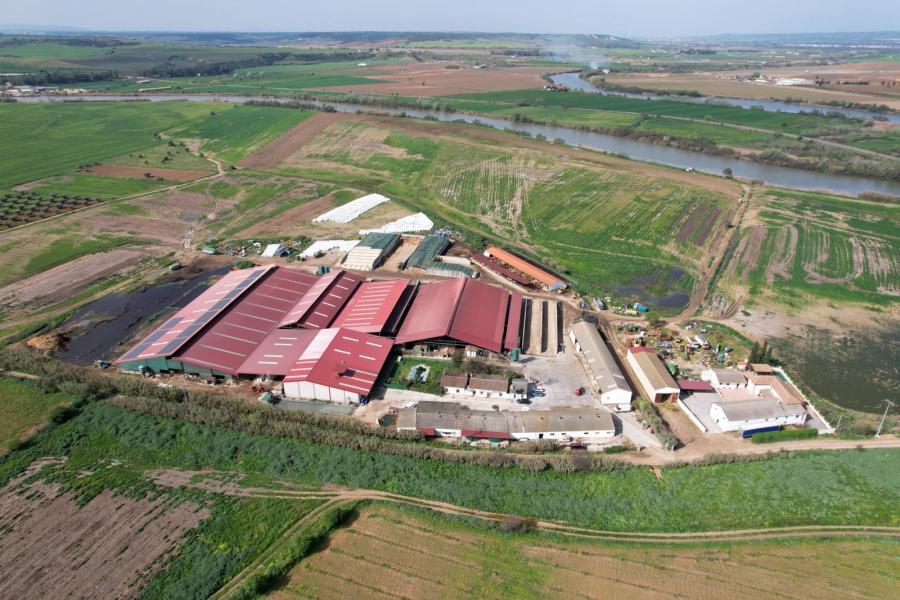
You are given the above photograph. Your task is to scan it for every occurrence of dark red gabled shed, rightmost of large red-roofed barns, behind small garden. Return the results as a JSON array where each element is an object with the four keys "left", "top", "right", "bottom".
[{"left": 396, "top": 278, "right": 522, "bottom": 353}]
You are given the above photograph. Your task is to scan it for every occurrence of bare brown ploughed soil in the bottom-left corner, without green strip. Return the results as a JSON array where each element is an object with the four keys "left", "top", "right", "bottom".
[{"left": 0, "top": 464, "right": 209, "bottom": 598}]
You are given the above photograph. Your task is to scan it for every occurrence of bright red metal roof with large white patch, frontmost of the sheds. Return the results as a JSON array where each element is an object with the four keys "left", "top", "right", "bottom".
[{"left": 284, "top": 328, "right": 391, "bottom": 395}]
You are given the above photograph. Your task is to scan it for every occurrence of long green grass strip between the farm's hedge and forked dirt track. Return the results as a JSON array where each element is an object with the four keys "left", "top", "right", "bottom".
[{"left": 0, "top": 402, "right": 900, "bottom": 531}]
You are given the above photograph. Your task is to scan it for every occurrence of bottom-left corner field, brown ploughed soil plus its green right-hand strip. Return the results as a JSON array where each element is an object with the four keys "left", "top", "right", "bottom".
[{"left": 0, "top": 428, "right": 317, "bottom": 599}]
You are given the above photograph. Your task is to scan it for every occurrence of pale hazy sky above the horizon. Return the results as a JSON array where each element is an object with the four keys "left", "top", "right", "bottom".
[{"left": 0, "top": 0, "right": 900, "bottom": 37}]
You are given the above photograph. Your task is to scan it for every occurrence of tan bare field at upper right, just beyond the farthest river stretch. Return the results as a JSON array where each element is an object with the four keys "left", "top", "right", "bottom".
[{"left": 606, "top": 72, "right": 900, "bottom": 109}]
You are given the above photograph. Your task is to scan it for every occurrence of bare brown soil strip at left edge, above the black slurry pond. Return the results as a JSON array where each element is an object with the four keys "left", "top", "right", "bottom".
[{"left": 0, "top": 247, "right": 153, "bottom": 309}]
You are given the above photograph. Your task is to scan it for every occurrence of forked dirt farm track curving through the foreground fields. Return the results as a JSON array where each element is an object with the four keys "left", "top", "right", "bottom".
[{"left": 149, "top": 470, "right": 900, "bottom": 599}]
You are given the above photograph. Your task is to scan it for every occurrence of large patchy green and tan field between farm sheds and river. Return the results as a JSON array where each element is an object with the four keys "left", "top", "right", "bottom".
[{"left": 282, "top": 121, "right": 733, "bottom": 304}]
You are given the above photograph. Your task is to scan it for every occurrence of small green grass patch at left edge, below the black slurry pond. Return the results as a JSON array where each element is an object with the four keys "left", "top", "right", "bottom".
[{"left": 0, "top": 377, "right": 75, "bottom": 455}]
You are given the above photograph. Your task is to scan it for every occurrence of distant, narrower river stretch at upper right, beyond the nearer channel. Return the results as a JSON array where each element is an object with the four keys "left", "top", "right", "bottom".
[{"left": 550, "top": 73, "right": 900, "bottom": 123}]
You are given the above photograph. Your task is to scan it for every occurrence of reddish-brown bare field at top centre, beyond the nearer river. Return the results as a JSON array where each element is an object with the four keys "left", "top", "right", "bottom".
[{"left": 316, "top": 62, "right": 552, "bottom": 96}]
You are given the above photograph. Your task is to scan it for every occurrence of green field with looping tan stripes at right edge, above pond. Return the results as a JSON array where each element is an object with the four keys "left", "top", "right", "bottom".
[{"left": 726, "top": 190, "right": 900, "bottom": 303}]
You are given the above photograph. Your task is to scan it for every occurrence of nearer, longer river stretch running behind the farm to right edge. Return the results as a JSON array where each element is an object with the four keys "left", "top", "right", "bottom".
[{"left": 19, "top": 94, "right": 900, "bottom": 196}]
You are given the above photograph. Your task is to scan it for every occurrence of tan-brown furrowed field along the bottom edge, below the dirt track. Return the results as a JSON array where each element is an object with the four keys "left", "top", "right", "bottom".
[{"left": 270, "top": 504, "right": 900, "bottom": 600}]
